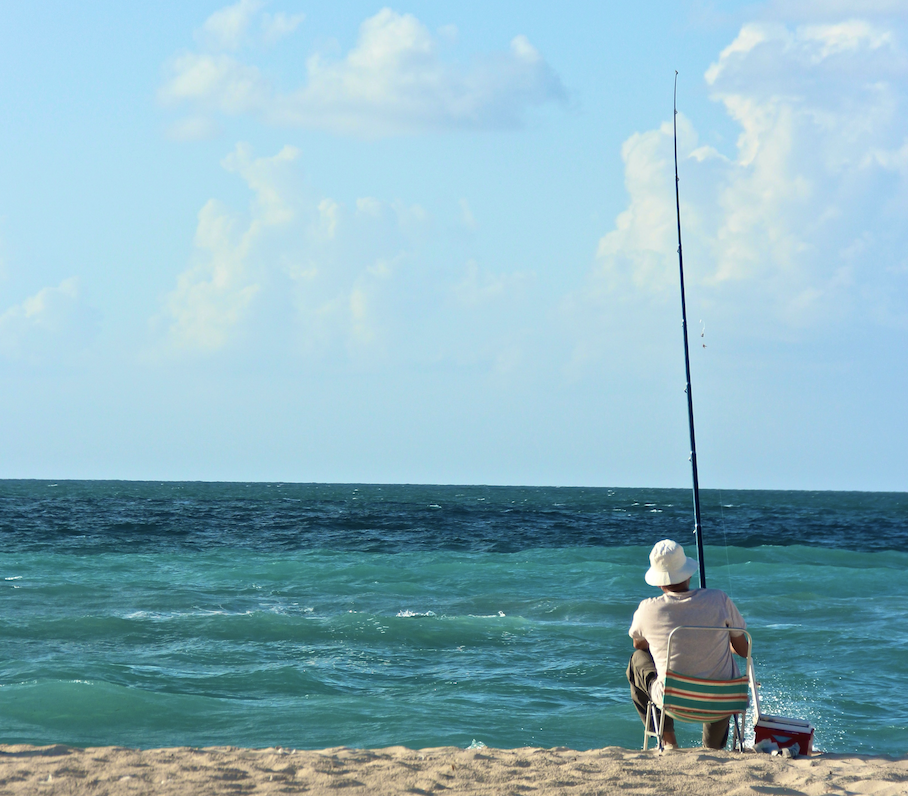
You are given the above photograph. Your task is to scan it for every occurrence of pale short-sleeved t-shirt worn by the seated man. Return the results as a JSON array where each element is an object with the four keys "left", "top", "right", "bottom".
[{"left": 628, "top": 589, "right": 747, "bottom": 705}]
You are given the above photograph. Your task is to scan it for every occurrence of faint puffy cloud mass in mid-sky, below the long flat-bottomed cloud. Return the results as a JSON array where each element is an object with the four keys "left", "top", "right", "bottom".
[{"left": 156, "top": 144, "right": 406, "bottom": 355}]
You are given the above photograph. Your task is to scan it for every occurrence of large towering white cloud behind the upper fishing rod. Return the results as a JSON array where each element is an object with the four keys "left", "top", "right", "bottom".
[{"left": 598, "top": 19, "right": 908, "bottom": 327}]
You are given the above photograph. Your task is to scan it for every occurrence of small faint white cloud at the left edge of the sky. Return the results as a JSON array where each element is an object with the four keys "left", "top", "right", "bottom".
[{"left": 0, "top": 277, "right": 97, "bottom": 361}]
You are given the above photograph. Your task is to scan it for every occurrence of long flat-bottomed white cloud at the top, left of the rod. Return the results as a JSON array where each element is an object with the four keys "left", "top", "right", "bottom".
[{"left": 159, "top": 5, "right": 566, "bottom": 137}]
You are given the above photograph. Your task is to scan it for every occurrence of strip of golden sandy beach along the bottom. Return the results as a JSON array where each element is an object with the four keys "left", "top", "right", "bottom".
[{"left": 0, "top": 746, "right": 908, "bottom": 796}]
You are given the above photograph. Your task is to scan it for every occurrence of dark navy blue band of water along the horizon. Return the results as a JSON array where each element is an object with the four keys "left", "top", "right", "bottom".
[{"left": 0, "top": 481, "right": 908, "bottom": 553}]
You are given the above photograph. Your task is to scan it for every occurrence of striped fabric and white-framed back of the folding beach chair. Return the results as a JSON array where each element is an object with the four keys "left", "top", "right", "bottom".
[{"left": 662, "top": 627, "right": 752, "bottom": 723}]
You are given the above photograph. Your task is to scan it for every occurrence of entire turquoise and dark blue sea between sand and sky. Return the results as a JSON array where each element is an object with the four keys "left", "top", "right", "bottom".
[{"left": 0, "top": 481, "right": 908, "bottom": 755}]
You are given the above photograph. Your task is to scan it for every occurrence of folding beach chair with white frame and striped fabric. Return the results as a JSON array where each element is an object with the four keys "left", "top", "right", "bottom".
[{"left": 643, "top": 627, "right": 753, "bottom": 752}]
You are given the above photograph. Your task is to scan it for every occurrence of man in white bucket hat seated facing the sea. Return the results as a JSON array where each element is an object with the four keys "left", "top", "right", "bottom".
[{"left": 627, "top": 539, "right": 747, "bottom": 749}]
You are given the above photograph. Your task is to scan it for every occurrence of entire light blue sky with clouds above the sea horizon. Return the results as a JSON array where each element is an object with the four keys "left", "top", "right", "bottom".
[{"left": 0, "top": 0, "right": 908, "bottom": 491}]
